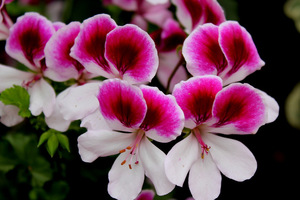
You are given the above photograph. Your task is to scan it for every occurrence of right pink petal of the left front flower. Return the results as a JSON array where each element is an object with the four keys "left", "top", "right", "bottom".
[{"left": 140, "top": 86, "right": 184, "bottom": 142}]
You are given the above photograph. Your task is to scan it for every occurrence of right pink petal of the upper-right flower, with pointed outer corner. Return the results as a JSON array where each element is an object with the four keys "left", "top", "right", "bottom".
[{"left": 219, "top": 21, "right": 265, "bottom": 85}]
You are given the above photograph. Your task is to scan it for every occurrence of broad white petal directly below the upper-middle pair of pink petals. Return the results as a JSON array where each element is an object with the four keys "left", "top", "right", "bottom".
[{"left": 59, "top": 82, "right": 100, "bottom": 120}]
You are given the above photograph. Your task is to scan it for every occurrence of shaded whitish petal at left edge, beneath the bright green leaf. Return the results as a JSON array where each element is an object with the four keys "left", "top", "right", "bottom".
[{"left": 0, "top": 101, "right": 24, "bottom": 127}]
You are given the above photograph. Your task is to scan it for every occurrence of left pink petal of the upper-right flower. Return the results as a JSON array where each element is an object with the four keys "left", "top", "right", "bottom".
[{"left": 182, "top": 24, "right": 228, "bottom": 76}]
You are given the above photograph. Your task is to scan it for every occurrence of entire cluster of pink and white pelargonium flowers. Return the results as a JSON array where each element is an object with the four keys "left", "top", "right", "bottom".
[{"left": 0, "top": 0, "right": 279, "bottom": 199}]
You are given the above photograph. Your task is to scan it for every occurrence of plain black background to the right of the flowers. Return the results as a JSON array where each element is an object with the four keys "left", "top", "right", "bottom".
[{"left": 219, "top": 0, "right": 300, "bottom": 199}]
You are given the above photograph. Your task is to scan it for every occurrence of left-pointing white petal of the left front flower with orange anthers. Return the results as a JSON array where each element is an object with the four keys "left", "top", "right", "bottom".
[{"left": 78, "top": 130, "right": 135, "bottom": 162}]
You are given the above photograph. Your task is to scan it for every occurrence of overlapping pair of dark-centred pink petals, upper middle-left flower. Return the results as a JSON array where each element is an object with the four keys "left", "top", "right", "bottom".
[{"left": 70, "top": 14, "right": 158, "bottom": 83}]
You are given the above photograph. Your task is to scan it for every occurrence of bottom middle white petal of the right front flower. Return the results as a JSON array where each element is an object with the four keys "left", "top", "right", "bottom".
[{"left": 189, "top": 154, "right": 222, "bottom": 200}]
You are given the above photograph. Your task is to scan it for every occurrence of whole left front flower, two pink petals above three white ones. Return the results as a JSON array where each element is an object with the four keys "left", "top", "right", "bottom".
[{"left": 78, "top": 79, "right": 184, "bottom": 199}]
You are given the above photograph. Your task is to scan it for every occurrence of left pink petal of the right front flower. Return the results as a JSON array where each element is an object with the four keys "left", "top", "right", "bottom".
[{"left": 173, "top": 76, "right": 222, "bottom": 128}]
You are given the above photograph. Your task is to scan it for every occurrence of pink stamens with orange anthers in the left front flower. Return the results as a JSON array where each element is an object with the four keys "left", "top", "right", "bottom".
[{"left": 120, "top": 129, "right": 145, "bottom": 169}]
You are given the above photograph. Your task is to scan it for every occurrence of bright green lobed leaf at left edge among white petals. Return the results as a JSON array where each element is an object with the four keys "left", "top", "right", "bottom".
[{"left": 0, "top": 85, "right": 31, "bottom": 117}]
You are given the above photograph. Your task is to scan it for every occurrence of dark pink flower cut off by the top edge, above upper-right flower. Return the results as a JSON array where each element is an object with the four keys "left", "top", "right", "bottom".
[{"left": 172, "top": 0, "right": 226, "bottom": 33}]
